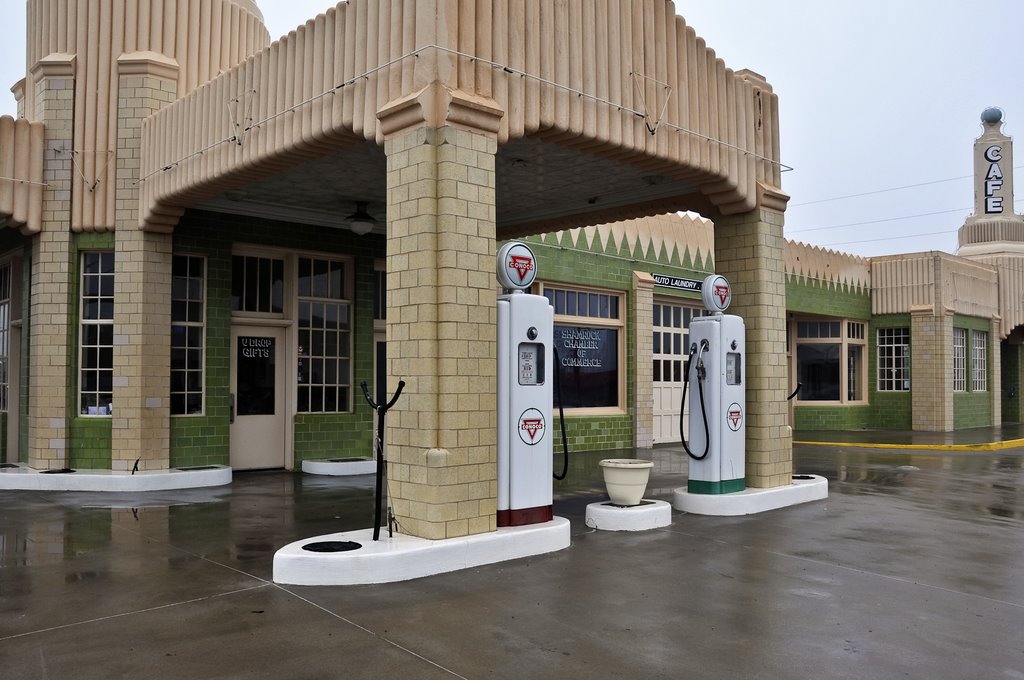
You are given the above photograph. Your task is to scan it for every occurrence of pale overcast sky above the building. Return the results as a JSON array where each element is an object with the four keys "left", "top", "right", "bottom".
[{"left": 0, "top": 0, "right": 1024, "bottom": 256}]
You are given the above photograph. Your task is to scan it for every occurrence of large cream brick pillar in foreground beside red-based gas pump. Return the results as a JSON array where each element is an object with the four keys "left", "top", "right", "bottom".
[{"left": 385, "top": 128, "right": 498, "bottom": 539}]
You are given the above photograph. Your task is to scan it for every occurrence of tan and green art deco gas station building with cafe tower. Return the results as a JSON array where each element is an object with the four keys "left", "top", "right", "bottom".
[{"left": 0, "top": 0, "right": 1024, "bottom": 539}]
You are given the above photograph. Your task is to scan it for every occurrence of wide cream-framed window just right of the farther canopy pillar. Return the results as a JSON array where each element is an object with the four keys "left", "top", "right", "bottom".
[{"left": 796, "top": 318, "right": 866, "bottom": 402}]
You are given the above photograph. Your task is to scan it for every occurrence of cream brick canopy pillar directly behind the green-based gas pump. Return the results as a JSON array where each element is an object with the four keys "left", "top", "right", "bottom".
[{"left": 715, "top": 203, "right": 793, "bottom": 488}]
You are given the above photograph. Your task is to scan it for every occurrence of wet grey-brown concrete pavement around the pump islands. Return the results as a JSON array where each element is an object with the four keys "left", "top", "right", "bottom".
[{"left": 0, "top": 444, "right": 1024, "bottom": 679}]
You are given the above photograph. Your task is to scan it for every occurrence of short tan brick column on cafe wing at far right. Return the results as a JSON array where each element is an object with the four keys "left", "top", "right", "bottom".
[{"left": 910, "top": 304, "right": 953, "bottom": 432}]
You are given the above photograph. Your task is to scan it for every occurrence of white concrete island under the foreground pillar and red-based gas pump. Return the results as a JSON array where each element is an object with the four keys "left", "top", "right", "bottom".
[{"left": 273, "top": 517, "right": 569, "bottom": 586}]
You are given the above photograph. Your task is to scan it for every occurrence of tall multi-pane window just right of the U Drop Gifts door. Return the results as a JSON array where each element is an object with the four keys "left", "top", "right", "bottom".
[{"left": 298, "top": 257, "right": 352, "bottom": 413}]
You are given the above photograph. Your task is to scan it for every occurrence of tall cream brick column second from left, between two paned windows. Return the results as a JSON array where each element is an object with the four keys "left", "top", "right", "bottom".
[{"left": 111, "top": 52, "right": 178, "bottom": 470}]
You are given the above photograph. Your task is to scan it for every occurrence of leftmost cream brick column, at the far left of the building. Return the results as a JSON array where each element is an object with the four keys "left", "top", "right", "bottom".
[{"left": 28, "top": 55, "right": 78, "bottom": 469}]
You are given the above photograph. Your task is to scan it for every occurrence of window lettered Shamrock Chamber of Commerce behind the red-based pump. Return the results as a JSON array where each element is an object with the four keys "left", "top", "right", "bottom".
[{"left": 542, "top": 285, "right": 626, "bottom": 410}]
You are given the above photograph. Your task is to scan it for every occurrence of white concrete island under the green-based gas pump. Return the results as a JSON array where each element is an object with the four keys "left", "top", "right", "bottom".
[{"left": 672, "top": 474, "right": 828, "bottom": 516}]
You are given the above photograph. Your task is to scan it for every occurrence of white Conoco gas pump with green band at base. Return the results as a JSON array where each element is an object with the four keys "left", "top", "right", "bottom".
[{"left": 679, "top": 274, "right": 746, "bottom": 494}]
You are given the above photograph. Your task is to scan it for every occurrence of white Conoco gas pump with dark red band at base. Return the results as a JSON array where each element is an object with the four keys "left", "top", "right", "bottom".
[{"left": 498, "top": 243, "right": 554, "bottom": 526}]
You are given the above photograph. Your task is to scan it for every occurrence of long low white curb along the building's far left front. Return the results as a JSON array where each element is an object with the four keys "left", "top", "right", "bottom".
[{"left": 0, "top": 465, "right": 231, "bottom": 492}]
